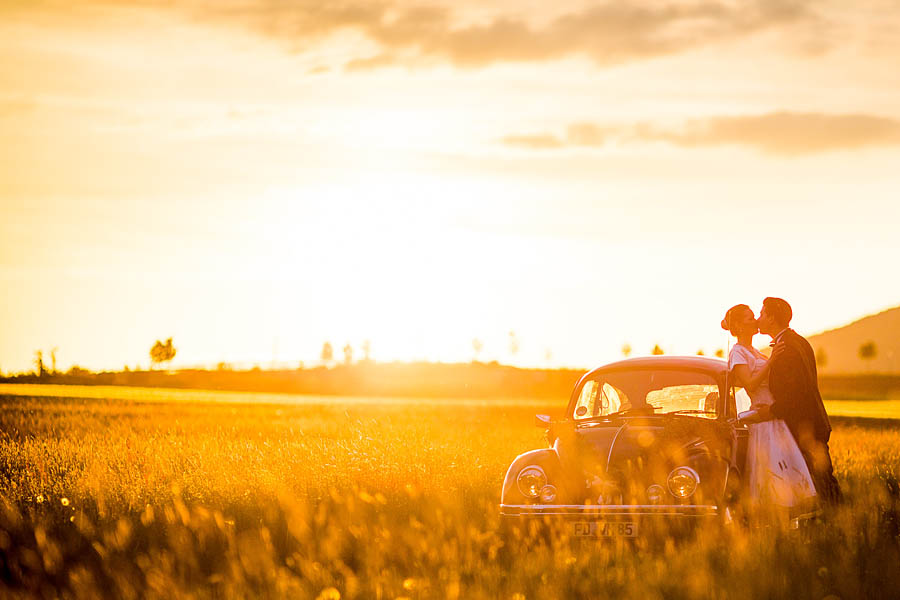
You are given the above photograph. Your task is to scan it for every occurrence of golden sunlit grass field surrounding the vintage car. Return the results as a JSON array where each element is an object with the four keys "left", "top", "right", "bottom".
[{"left": 0, "top": 388, "right": 900, "bottom": 600}]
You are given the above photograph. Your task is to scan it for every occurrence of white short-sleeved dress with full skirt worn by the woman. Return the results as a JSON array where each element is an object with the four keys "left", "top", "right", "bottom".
[{"left": 728, "top": 344, "right": 816, "bottom": 507}]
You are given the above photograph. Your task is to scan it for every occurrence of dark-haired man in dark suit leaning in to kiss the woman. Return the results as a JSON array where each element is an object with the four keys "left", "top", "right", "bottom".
[{"left": 759, "top": 298, "right": 841, "bottom": 505}]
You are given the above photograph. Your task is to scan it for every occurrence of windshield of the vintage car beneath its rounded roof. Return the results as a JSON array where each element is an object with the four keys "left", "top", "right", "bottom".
[{"left": 572, "top": 369, "right": 719, "bottom": 419}]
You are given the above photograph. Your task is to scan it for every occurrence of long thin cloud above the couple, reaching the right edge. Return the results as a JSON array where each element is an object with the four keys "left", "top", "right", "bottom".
[{"left": 501, "top": 111, "right": 900, "bottom": 156}]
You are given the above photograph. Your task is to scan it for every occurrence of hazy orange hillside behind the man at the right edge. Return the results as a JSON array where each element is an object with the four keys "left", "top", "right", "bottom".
[{"left": 807, "top": 306, "right": 900, "bottom": 375}]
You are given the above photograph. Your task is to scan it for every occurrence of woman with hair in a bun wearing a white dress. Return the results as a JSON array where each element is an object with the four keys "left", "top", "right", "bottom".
[{"left": 722, "top": 304, "right": 816, "bottom": 510}]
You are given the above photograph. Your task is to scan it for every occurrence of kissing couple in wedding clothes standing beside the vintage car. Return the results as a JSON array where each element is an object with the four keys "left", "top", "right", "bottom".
[{"left": 722, "top": 298, "right": 841, "bottom": 509}]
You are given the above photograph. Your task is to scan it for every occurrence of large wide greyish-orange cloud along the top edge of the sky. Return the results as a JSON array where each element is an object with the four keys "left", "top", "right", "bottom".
[{"left": 234, "top": 0, "right": 814, "bottom": 69}]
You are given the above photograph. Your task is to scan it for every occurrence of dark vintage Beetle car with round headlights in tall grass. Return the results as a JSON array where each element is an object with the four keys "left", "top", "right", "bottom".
[{"left": 500, "top": 356, "right": 749, "bottom": 537}]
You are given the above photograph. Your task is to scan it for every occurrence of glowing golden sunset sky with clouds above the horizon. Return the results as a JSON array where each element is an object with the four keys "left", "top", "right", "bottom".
[{"left": 0, "top": 0, "right": 900, "bottom": 372}]
